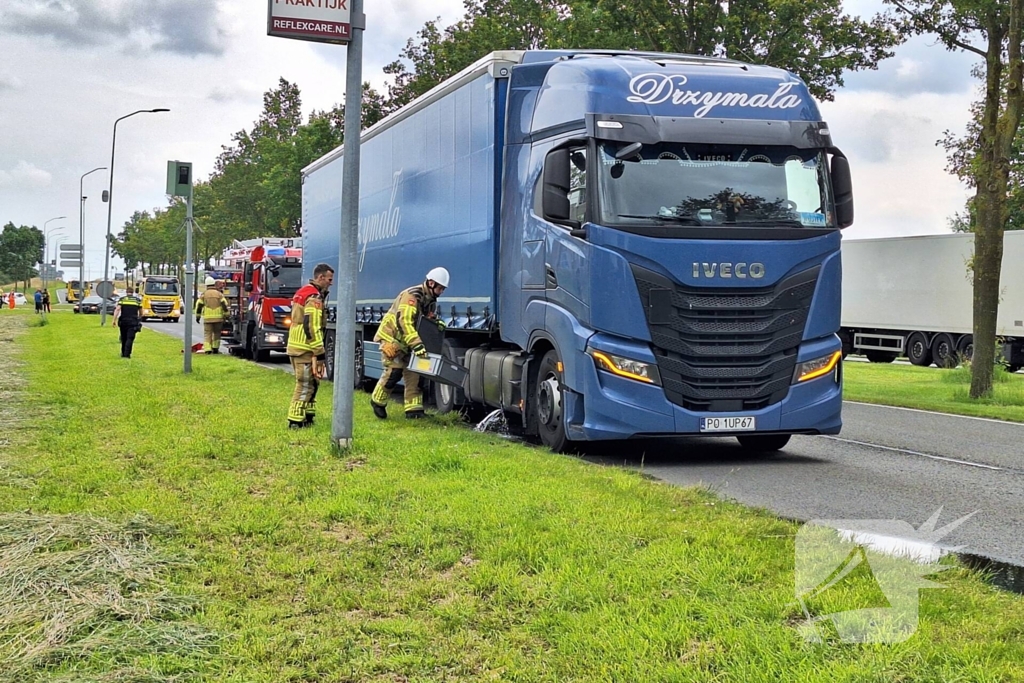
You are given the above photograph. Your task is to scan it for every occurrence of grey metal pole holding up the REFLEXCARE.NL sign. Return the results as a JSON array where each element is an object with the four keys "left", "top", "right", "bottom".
[{"left": 331, "top": 0, "right": 367, "bottom": 449}]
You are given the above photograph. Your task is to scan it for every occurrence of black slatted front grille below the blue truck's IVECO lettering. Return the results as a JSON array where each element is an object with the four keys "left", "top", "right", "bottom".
[{"left": 632, "top": 265, "right": 820, "bottom": 413}]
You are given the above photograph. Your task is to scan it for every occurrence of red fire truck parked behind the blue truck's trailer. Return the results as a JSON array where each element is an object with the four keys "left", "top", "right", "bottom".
[{"left": 217, "top": 238, "right": 302, "bottom": 361}]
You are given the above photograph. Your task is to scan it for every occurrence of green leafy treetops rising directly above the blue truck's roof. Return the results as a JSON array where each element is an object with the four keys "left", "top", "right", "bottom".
[{"left": 384, "top": 0, "right": 901, "bottom": 109}]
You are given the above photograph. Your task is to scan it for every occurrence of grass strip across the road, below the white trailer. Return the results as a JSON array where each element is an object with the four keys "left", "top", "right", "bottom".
[{"left": 843, "top": 362, "right": 1024, "bottom": 422}]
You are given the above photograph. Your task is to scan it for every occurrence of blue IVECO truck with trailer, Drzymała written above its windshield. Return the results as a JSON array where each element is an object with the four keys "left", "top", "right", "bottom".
[{"left": 302, "top": 50, "right": 853, "bottom": 452}]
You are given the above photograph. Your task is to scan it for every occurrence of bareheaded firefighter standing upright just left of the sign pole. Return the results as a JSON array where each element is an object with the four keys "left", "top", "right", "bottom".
[{"left": 288, "top": 263, "right": 334, "bottom": 429}]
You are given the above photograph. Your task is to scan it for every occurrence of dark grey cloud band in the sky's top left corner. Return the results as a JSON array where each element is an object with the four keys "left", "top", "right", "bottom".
[{"left": 0, "top": 0, "right": 224, "bottom": 56}]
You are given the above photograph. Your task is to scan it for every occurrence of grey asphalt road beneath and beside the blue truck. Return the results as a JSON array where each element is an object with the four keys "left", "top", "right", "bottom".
[{"left": 146, "top": 321, "right": 1024, "bottom": 565}]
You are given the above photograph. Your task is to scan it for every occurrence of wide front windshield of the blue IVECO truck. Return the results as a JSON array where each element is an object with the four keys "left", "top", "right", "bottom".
[{"left": 597, "top": 142, "right": 836, "bottom": 229}]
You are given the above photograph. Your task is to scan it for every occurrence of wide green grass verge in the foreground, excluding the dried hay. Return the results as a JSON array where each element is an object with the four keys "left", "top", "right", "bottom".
[{"left": 6, "top": 315, "right": 1024, "bottom": 683}]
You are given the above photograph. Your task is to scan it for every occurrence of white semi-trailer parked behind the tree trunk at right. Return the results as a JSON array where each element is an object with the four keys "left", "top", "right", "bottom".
[{"left": 840, "top": 230, "right": 1024, "bottom": 372}]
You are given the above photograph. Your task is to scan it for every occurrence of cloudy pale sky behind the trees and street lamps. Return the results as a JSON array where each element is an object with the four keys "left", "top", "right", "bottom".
[{"left": 0, "top": 0, "right": 977, "bottom": 280}]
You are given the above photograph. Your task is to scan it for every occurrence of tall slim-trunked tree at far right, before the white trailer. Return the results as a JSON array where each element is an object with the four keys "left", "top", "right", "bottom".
[{"left": 886, "top": 0, "right": 1024, "bottom": 398}]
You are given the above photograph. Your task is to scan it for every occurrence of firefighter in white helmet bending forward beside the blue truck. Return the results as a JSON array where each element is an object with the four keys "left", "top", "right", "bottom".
[{"left": 370, "top": 268, "right": 449, "bottom": 420}]
